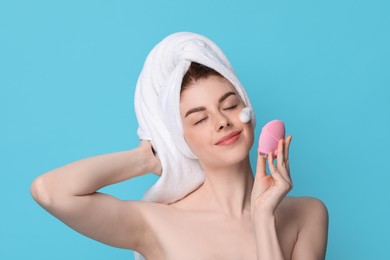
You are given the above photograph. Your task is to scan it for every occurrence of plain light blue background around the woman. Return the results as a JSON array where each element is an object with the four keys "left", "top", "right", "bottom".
[{"left": 0, "top": 0, "right": 390, "bottom": 260}]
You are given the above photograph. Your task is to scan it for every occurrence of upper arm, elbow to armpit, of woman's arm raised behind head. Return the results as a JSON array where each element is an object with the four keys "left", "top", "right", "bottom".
[{"left": 32, "top": 177, "right": 148, "bottom": 251}]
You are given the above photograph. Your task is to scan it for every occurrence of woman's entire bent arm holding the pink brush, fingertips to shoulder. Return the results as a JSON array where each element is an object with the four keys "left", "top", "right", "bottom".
[{"left": 251, "top": 136, "right": 328, "bottom": 260}]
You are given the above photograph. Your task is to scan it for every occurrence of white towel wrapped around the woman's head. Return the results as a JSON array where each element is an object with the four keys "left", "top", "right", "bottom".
[{"left": 134, "top": 32, "right": 255, "bottom": 259}]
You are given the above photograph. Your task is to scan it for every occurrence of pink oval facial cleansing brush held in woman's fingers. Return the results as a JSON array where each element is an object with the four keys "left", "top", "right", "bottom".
[{"left": 257, "top": 120, "right": 285, "bottom": 158}]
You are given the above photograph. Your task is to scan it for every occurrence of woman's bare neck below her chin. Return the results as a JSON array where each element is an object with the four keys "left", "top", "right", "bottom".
[{"left": 198, "top": 157, "right": 254, "bottom": 218}]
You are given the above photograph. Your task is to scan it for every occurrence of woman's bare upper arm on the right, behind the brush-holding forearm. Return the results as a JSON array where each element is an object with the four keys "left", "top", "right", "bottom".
[{"left": 291, "top": 198, "right": 328, "bottom": 260}]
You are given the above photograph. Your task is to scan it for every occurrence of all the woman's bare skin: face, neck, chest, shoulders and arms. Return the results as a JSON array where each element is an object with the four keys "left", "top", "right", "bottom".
[{"left": 31, "top": 76, "right": 328, "bottom": 260}]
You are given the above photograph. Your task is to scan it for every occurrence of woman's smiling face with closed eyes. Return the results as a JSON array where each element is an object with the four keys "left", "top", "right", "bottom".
[{"left": 180, "top": 76, "right": 253, "bottom": 167}]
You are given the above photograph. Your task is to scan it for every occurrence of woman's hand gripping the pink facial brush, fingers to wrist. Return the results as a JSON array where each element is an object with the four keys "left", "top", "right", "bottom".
[{"left": 251, "top": 135, "right": 293, "bottom": 216}]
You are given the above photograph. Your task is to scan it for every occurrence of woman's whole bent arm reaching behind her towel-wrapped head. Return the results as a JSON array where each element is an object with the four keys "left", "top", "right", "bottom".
[{"left": 31, "top": 141, "right": 161, "bottom": 251}]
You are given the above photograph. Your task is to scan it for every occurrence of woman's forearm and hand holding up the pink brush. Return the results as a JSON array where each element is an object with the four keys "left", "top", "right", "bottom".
[{"left": 251, "top": 136, "right": 292, "bottom": 260}]
